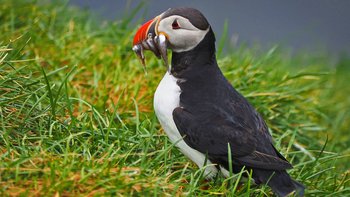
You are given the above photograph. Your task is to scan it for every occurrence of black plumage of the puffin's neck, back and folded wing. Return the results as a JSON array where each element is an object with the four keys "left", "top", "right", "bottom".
[{"left": 171, "top": 29, "right": 291, "bottom": 170}]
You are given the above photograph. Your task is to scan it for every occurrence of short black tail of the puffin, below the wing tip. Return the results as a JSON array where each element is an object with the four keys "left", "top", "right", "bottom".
[{"left": 253, "top": 169, "right": 305, "bottom": 197}]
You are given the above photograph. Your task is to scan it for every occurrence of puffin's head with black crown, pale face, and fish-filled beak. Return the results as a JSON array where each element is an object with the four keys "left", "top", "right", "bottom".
[{"left": 133, "top": 7, "right": 215, "bottom": 69}]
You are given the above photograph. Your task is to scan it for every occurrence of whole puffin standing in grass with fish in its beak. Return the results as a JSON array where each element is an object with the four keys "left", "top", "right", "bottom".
[{"left": 132, "top": 7, "right": 305, "bottom": 196}]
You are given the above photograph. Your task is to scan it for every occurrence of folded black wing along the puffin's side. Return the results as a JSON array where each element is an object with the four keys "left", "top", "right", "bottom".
[{"left": 173, "top": 103, "right": 292, "bottom": 170}]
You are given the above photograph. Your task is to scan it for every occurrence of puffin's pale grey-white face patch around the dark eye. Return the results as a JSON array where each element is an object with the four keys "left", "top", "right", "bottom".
[{"left": 157, "top": 15, "right": 209, "bottom": 52}]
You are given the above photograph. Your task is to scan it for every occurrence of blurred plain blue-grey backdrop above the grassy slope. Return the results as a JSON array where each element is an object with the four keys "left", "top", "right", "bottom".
[{"left": 69, "top": 0, "right": 350, "bottom": 55}]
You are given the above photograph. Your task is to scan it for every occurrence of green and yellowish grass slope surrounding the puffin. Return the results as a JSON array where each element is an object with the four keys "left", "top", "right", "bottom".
[{"left": 0, "top": 0, "right": 350, "bottom": 196}]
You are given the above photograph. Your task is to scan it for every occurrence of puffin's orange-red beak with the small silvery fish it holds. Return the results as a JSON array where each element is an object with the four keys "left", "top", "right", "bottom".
[{"left": 132, "top": 16, "right": 168, "bottom": 70}]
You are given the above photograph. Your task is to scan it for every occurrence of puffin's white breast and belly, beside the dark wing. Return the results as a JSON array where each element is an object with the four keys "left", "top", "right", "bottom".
[{"left": 154, "top": 72, "right": 217, "bottom": 177}]
